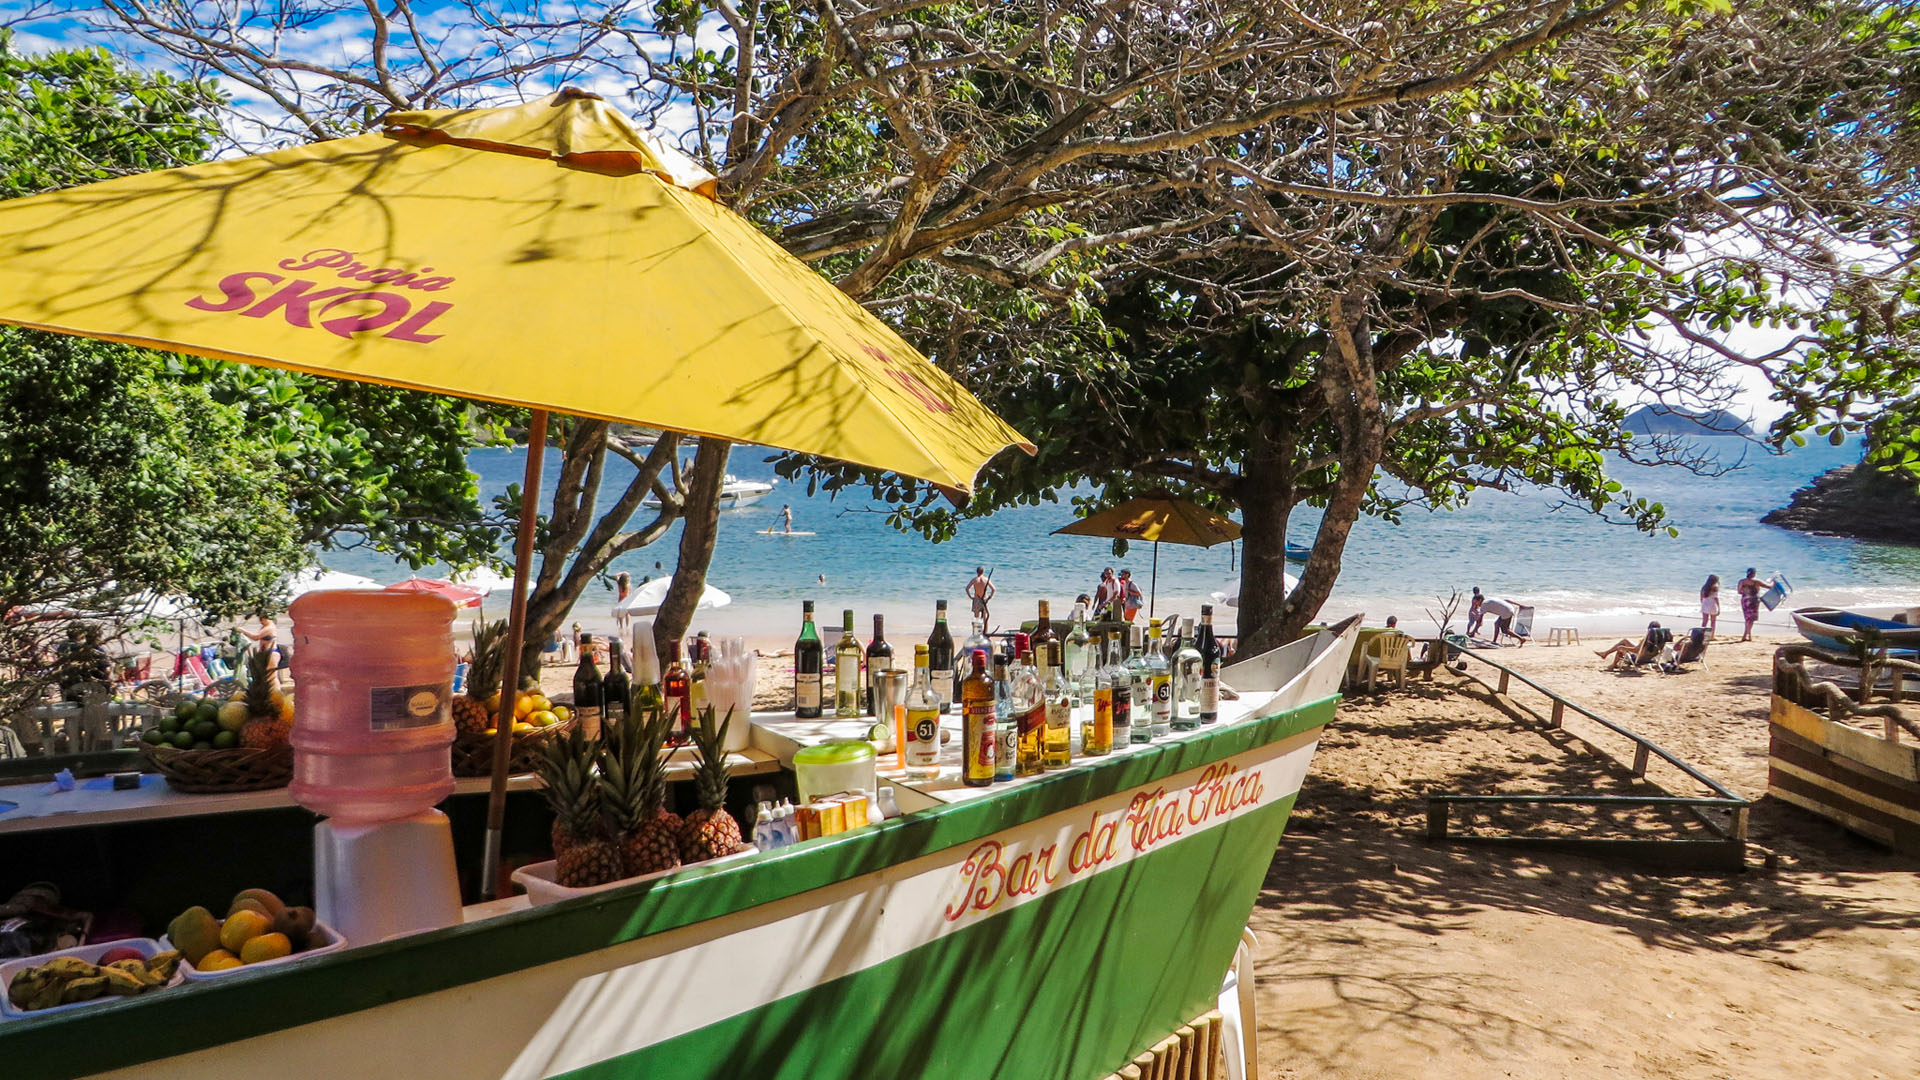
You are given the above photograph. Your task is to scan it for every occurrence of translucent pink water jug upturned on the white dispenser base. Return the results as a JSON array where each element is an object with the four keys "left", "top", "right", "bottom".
[{"left": 290, "top": 590, "right": 453, "bottom": 822}]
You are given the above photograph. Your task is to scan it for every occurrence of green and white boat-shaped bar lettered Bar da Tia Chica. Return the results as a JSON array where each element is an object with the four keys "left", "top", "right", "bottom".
[{"left": 0, "top": 621, "right": 1357, "bottom": 1080}]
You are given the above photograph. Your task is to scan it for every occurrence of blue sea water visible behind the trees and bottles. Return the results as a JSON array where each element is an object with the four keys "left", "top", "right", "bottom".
[{"left": 321, "top": 438, "right": 1920, "bottom": 638}]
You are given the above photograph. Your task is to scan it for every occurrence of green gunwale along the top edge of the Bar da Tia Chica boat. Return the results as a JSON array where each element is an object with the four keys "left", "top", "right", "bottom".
[{"left": 0, "top": 691, "right": 1338, "bottom": 1076}]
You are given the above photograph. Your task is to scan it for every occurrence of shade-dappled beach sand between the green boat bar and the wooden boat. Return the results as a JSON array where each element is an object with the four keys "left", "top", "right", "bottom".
[{"left": 1252, "top": 640, "right": 1920, "bottom": 1080}]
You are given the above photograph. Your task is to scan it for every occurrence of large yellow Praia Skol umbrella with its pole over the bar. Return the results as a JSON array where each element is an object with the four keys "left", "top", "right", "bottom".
[{"left": 0, "top": 90, "right": 1031, "bottom": 890}]
